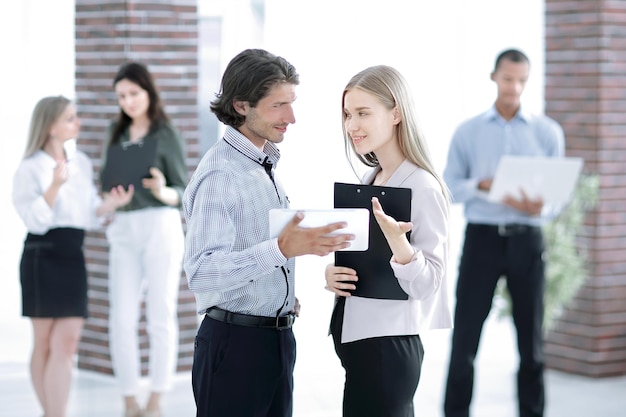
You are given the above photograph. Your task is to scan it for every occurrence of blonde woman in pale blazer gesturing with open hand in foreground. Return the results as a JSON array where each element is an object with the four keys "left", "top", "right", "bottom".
[{"left": 326, "top": 65, "right": 452, "bottom": 417}]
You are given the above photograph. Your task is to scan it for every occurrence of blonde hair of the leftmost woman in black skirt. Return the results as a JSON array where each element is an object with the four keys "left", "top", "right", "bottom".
[{"left": 24, "top": 96, "right": 70, "bottom": 158}]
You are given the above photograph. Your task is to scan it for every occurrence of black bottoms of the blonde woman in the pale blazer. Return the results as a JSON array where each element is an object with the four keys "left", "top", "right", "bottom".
[{"left": 331, "top": 298, "right": 424, "bottom": 417}]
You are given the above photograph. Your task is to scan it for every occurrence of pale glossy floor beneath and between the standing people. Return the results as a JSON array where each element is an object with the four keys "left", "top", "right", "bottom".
[{"left": 0, "top": 288, "right": 626, "bottom": 417}]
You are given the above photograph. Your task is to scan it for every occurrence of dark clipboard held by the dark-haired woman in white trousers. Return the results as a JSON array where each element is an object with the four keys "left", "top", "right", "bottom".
[{"left": 100, "top": 138, "right": 157, "bottom": 192}]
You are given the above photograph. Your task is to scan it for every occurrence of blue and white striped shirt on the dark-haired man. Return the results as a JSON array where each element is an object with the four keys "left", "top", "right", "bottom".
[{"left": 183, "top": 127, "right": 295, "bottom": 317}]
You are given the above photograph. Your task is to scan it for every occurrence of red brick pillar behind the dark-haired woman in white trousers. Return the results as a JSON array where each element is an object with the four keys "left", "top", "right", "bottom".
[{"left": 75, "top": 0, "right": 199, "bottom": 375}]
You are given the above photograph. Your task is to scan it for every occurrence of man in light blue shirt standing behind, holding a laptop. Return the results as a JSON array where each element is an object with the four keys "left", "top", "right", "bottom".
[{"left": 444, "top": 49, "right": 565, "bottom": 417}]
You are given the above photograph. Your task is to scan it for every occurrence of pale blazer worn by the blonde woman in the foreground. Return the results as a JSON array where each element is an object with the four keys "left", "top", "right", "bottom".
[{"left": 341, "top": 160, "right": 452, "bottom": 343}]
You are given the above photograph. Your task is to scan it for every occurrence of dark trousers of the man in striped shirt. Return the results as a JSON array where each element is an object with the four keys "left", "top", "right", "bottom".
[{"left": 191, "top": 316, "right": 296, "bottom": 417}]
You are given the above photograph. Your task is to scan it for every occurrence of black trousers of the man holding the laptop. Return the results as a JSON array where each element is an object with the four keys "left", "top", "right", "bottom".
[{"left": 444, "top": 224, "right": 545, "bottom": 417}]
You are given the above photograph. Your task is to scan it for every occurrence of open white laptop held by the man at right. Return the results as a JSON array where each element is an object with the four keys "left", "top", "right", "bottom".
[{"left": 487, "top": 155, "right": 583, "bottom": 205}]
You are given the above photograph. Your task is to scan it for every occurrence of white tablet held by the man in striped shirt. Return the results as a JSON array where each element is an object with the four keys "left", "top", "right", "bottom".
[{"left": 270, "top": 208, "right": 370, "bottom": 251}]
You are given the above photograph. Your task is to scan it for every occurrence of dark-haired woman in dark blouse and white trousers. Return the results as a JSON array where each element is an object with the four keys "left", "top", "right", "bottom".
[{"left": 102, "top": 62, "right": 187, "bottom": 417}]
